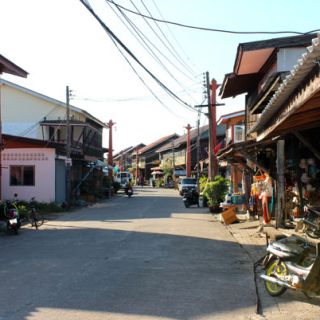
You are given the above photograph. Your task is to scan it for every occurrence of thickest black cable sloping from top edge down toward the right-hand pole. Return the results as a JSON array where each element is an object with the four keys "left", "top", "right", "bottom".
[{"left": 80, "top": 0, "right": 195, "bottom": 111}]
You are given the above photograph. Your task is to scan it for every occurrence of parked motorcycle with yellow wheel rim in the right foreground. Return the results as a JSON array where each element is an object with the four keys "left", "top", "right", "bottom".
[{"left": 260, "top": 235, "right": 320, "bottom": 297}]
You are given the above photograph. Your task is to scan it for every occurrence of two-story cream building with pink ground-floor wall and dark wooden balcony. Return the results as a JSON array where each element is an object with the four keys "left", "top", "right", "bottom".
[{"left": 0, "top": 79, "right": 106, "bottom": 203}]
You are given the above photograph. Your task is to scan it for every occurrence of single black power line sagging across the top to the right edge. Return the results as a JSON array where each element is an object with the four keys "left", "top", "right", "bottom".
[{"left": 107, "top": 0, "right": 320, "bottom": 35}]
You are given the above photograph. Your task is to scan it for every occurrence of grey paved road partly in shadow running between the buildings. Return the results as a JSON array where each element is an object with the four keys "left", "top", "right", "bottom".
[{"left": 0, "top": 188, "right": 256, "bottom": 320}]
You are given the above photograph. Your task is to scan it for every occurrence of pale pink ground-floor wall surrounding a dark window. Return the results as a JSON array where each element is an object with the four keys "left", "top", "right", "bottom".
[{"left": 2, "top": 148, "right": 55, "bottom": 202}]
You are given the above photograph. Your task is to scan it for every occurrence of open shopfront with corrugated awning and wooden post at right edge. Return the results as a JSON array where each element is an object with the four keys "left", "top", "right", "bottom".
[{"left": 249, "top": 35, "right": 320, "bottom": 225}]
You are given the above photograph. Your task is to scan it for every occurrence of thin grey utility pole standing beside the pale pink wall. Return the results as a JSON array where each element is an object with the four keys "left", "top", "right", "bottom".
[{"left": 65, "top": 86, "right": 71, "bottom": 207}]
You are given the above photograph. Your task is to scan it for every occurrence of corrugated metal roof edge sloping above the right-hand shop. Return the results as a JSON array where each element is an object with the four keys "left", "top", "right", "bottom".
[{"left": 249, "top": 33, "right": 320, "bottom": 133}]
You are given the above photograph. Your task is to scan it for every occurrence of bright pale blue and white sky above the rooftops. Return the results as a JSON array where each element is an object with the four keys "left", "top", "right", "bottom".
[{"left": 0, "top": 0, "right": 320, "bottom": 151}]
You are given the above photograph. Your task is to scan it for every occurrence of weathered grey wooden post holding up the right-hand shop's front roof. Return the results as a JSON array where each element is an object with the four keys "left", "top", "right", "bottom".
[{"left": 276, "top": 140, "right": 285, "bottom": 228}]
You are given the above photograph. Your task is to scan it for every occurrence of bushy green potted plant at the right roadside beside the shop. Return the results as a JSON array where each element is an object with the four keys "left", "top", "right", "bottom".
[{"left": 203, "top": 176, "right": 229, "bottom": 212}]
